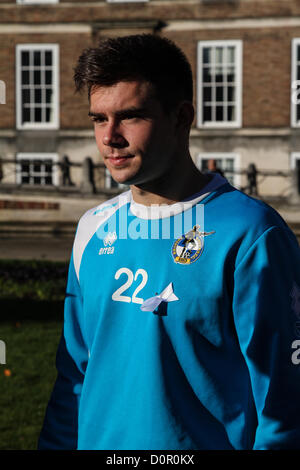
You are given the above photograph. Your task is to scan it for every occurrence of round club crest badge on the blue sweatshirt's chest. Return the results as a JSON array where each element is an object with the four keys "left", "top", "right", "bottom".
[{"left": 172, "top": 225, "right": 215, "bottom": 265}]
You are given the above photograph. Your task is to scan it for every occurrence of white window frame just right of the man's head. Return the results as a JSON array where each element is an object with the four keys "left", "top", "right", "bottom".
[{"left": 197, "top": 39, "right": 243, "bottom": 128}]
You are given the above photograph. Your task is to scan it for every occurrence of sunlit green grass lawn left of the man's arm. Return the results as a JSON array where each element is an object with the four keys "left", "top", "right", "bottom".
[{"left": 0, "top": 320, "right": 61, "bottom": 450}]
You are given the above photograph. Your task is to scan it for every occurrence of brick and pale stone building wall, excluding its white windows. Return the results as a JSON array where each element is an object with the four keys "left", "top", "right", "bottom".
[{"left": 0, "top": 0, "right": 300, "bottom": 195}]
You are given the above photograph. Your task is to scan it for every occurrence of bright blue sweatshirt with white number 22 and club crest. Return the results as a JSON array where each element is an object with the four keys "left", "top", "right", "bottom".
[{"left": 39, "top": 176, "right": 300, "bottom": 450}]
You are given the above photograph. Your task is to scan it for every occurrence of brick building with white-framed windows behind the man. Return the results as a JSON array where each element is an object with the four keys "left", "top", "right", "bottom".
[{"left": 0, "top": 0, "right": 300, "bottom": 206}]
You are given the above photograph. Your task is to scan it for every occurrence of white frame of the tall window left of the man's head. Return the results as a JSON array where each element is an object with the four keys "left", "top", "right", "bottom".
[{"left": 16, "top": 44, "right": 59, "bottom": 130}]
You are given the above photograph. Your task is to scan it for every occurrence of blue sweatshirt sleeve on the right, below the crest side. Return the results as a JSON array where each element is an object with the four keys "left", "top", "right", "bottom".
[{"left": 233, "top": 227, "right": 300, "bottom": 449}]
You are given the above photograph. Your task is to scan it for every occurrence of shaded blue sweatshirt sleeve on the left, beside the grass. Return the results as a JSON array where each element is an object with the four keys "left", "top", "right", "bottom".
[{"left": 38, "top": 252, "right": 88, "bottom": 450}]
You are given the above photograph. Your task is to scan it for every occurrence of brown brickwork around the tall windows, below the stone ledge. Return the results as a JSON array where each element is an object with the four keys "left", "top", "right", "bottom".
[{"left": 0, "top": 22, "right": 300, "bottom": 129}]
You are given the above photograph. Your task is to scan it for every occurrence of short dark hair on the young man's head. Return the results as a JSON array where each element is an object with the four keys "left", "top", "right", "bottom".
[{"left": 74, "top": 34, "right": 193, "bottom": 112}]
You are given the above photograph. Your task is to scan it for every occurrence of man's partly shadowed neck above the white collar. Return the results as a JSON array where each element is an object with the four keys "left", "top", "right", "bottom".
[{"left": 130, "top": 161, "right": 211, "bottom": 206}]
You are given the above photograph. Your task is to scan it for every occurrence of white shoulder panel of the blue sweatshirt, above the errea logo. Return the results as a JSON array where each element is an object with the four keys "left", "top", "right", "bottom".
[{"left": 73, "top": 191, "right": 131, "bottom": 281}]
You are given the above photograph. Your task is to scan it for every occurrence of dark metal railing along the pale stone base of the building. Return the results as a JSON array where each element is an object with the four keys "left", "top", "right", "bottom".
[{"left": 0, "top": 155, "right": 300, "bottom": 203}]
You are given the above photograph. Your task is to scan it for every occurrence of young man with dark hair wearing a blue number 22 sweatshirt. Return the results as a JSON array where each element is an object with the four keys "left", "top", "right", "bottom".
[{"left": 39, "top": 35, "right": 300, "bottom": 450}]
